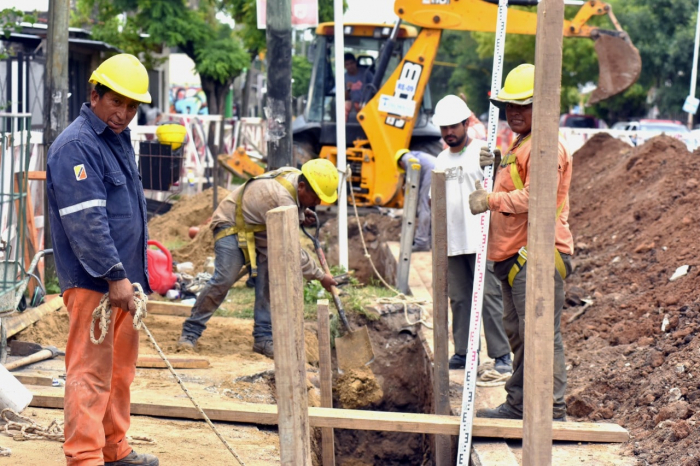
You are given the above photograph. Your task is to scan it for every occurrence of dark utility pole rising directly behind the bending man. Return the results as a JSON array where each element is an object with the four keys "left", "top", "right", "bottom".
[{"left": 265, "top": 0, "right": 292, "bottom": 170}]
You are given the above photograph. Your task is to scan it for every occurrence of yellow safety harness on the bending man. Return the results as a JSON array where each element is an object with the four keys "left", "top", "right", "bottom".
[{"left": 214, "top": 168, "right": 301, "bottom": 277}]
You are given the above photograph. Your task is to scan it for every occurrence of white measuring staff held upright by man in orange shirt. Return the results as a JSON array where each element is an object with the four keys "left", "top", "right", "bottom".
[{"left": 457, "top": 0, "right": 508, "bottom": 466}]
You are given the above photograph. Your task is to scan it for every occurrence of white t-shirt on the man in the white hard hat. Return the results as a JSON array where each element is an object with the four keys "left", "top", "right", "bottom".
[{"left": 435, "top": 139, "right": 485, "bottom": 256}]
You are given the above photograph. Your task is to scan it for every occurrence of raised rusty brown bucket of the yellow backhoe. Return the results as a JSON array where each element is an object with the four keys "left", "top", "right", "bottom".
[{"left": 588, "top": 31, "right": 642, "bottom": 105}]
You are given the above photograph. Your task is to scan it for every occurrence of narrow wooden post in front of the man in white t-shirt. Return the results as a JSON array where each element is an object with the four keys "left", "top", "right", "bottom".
[{"left": 430, "top": 170, "right": 453, "bottom": 466}]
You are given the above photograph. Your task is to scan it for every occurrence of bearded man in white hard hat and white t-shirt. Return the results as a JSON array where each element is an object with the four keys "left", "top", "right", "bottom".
[{"left": 433, "top": 95, "right": 510, "bottom": 369}]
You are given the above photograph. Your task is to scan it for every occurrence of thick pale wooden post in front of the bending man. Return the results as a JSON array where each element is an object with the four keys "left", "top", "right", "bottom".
[{"left": 266, "top": 206, "right": 311, "bottom": 466}]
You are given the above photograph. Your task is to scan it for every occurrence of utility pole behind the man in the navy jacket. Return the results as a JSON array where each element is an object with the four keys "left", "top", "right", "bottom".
[{"left": 44, "top": 0, "right": 70, "bottom": 282}]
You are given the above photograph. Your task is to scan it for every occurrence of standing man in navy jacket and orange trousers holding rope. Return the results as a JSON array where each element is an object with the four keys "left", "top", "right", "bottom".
[{"left": 46, "top": 54, "right": 158, "bottom": 466}]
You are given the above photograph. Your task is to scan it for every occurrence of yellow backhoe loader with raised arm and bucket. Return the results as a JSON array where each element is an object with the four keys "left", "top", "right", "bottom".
[{"left": 292, "top": 0, "right": 641, "bottom": 207}]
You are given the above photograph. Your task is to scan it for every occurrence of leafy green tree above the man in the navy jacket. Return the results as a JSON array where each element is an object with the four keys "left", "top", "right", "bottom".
[{"left": 73, "top": 0, "right": 248, "bottom": 118}]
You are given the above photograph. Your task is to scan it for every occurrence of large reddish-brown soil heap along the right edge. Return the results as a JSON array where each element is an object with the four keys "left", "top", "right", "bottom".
[{"left": 562, "top": 134, "right": 700, "bottom": 466}]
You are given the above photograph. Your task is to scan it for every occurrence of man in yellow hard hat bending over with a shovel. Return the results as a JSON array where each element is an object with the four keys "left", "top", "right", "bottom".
[{"left": 178, "top": 159, "right": 338, "bottom": 358}]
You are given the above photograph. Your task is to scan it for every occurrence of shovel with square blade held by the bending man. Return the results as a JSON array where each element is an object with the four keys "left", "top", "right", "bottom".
[{"left": 301, "top": 212, "right": 374, "bottom": 371}]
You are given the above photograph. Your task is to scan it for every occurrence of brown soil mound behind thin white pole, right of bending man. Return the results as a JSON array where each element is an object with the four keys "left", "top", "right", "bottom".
[{"left": 319, "top": 210, "right": 401, "bottom": 283}]
